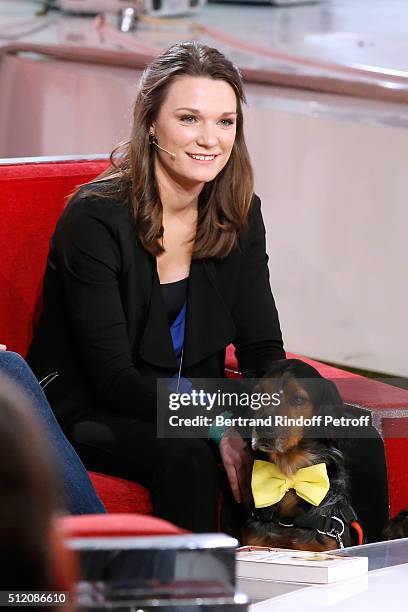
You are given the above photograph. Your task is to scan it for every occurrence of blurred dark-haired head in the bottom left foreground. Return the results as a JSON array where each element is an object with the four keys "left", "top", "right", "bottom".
[{"left": 0, "top": 377, "right": 66, "bottom": 590}]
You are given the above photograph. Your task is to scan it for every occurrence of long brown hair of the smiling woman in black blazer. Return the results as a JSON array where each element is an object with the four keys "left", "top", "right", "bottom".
[{"left": 81, "top": 41, "right": 253, "bottom": 259}]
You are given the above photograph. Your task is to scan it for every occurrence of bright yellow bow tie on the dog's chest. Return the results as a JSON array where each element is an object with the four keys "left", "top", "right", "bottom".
[{"left": 251, "top": 460, "right": 330, "bottom": 508}]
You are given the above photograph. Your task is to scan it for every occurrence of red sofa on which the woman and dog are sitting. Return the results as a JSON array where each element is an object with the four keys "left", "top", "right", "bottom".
[{"left": 0, "top": 159, "right": 408, "bottom": 514}]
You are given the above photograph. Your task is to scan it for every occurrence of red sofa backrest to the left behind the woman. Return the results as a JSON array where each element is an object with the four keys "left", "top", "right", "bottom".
[{"left": 0, "top": 159, "right": 107, "bottom": 355}]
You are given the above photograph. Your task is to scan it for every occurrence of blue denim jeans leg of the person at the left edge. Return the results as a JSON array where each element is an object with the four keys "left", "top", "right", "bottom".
[{"left": 0, "top": 351, "right": 105, "bottom": 514}]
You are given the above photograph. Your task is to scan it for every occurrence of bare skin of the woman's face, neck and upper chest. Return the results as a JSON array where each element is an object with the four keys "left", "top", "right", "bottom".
[{"left": 149, "top": 76, "right": 237, "bottom": 283}]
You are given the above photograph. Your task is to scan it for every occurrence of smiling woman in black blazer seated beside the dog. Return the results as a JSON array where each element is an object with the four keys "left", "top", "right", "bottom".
[{"left": 29, "top": 42, "right": 285, "bottom": 531}]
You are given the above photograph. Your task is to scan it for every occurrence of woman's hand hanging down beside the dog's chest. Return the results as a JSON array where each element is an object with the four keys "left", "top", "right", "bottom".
[{"left": 219, "top": 427, "right": 252, "bottom": 507}]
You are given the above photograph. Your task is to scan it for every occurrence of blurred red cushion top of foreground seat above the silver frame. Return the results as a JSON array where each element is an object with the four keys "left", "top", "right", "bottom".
[{"left": 58, "top": 514, "right": 188, "bottom": 538}]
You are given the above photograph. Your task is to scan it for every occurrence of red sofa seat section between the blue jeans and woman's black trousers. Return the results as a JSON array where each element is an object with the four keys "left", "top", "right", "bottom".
[{"left": 89, "top": 472, "right": 152, "bottom": 514}]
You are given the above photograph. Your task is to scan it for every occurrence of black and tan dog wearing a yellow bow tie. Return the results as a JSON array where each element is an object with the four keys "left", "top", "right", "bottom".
[{"left": 242, "top": 359, "right": 364, "bottom": 552}]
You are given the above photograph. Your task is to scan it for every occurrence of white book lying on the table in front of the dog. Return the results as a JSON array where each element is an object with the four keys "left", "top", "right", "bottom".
[{"left": 236, "top": 546, "right": 368, "bottom": 584}]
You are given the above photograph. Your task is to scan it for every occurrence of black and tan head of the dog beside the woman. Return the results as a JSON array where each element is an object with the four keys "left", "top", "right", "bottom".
[{"left": 252, "top": 359, "right": 343, "bottom": 453}]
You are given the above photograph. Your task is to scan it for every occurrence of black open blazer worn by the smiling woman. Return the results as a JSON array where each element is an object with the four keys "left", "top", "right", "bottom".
[{"left": 27, "top": 186, "right": 285, "bottom": 425}]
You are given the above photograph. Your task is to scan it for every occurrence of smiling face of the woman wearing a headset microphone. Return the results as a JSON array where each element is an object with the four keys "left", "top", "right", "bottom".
[{"left": 152, "top": 76, "right": 237, "bottom": 187}]
